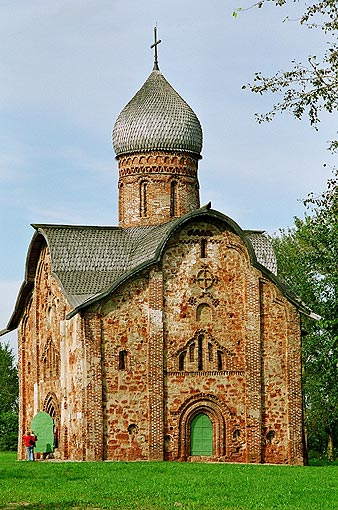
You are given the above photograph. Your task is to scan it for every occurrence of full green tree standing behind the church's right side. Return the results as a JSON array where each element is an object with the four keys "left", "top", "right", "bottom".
[{"left": 273, "top": 170, "right": 338, "bottom": 460}]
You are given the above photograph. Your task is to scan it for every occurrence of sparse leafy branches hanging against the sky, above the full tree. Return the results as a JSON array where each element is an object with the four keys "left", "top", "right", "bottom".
[{"left": 238, "top": 0, "right": 338, "bottom": 151}]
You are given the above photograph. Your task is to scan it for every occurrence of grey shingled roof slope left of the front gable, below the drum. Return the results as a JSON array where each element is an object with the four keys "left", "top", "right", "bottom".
[{"left": 33, "top": 224, "right": 174, "bottom": 307}]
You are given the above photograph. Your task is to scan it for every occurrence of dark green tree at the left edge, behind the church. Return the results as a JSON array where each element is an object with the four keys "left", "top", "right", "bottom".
[{"left": 0, "top": 343, "right": 18, "bottom": 450}]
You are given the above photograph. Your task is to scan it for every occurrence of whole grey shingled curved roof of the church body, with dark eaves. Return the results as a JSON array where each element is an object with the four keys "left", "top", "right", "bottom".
[{"left": 0, "top": 204, "right": 299, "bottom": 335}]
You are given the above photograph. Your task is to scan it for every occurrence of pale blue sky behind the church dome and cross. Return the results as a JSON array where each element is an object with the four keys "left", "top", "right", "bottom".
[{"left": 0, "top": 0, "right": 337, "bottom": 356}]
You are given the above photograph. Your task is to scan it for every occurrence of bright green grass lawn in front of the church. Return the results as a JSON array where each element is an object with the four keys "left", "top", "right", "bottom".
[{"left": 0, "top": 453, "right": 338, "bottom": 510}]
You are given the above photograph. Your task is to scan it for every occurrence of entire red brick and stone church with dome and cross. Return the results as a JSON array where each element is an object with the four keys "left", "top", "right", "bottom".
[{"left": 1, "top": 32, "right": 305, "bottom": 465}]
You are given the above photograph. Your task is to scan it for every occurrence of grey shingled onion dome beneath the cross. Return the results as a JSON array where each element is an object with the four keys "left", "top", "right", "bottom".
[{"left": 113, "top": 69, "right": 202, "bottom": 156}]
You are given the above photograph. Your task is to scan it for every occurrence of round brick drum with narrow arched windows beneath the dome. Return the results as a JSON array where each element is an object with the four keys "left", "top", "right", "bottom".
[{"left": 118, "top": 151, "right": 200, "bottom": 227}]
